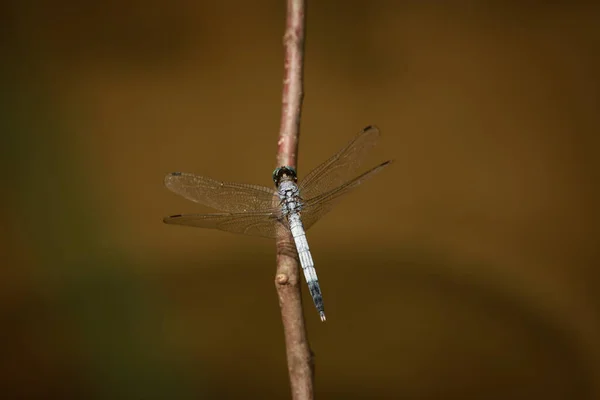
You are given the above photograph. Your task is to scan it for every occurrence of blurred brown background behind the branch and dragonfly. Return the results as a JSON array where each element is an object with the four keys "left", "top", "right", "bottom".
[{"left": 0, "top": 0, "right": 600, "bottom": 399}]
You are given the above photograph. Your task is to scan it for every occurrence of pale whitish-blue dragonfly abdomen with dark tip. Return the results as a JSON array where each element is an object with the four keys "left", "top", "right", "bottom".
[{"left": 288, "top": 213, "right": 325, "bottom": 321}]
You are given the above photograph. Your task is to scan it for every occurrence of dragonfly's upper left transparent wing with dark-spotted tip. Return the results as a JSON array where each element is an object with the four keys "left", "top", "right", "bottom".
[{"left": 165, "top": 172, "right": 276, "bottom": 213}]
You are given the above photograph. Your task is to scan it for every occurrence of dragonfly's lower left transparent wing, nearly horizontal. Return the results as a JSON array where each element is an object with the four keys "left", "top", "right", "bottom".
[{"left": 163, "top": 209, "right": 281, "bottom": 238}]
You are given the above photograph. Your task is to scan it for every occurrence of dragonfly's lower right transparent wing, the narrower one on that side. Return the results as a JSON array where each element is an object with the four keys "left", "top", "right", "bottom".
[{"left": 302, "top": 160, "right": 393, "bottom": 230}]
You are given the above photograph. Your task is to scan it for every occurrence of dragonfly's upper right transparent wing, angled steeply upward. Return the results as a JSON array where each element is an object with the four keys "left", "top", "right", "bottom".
[{"left": 298, "top": 126, "right": 379, "bottom": 200}]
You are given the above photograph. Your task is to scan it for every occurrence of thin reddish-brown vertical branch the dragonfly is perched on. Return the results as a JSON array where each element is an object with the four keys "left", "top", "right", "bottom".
[{"left": 275, "top": 0, "right": 314, "bottom": 400}]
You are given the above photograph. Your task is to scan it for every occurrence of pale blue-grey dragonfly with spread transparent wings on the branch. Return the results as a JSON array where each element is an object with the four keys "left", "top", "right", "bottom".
[{"left": 163, "top": 125, "right": 393, "bottom": 321}]
